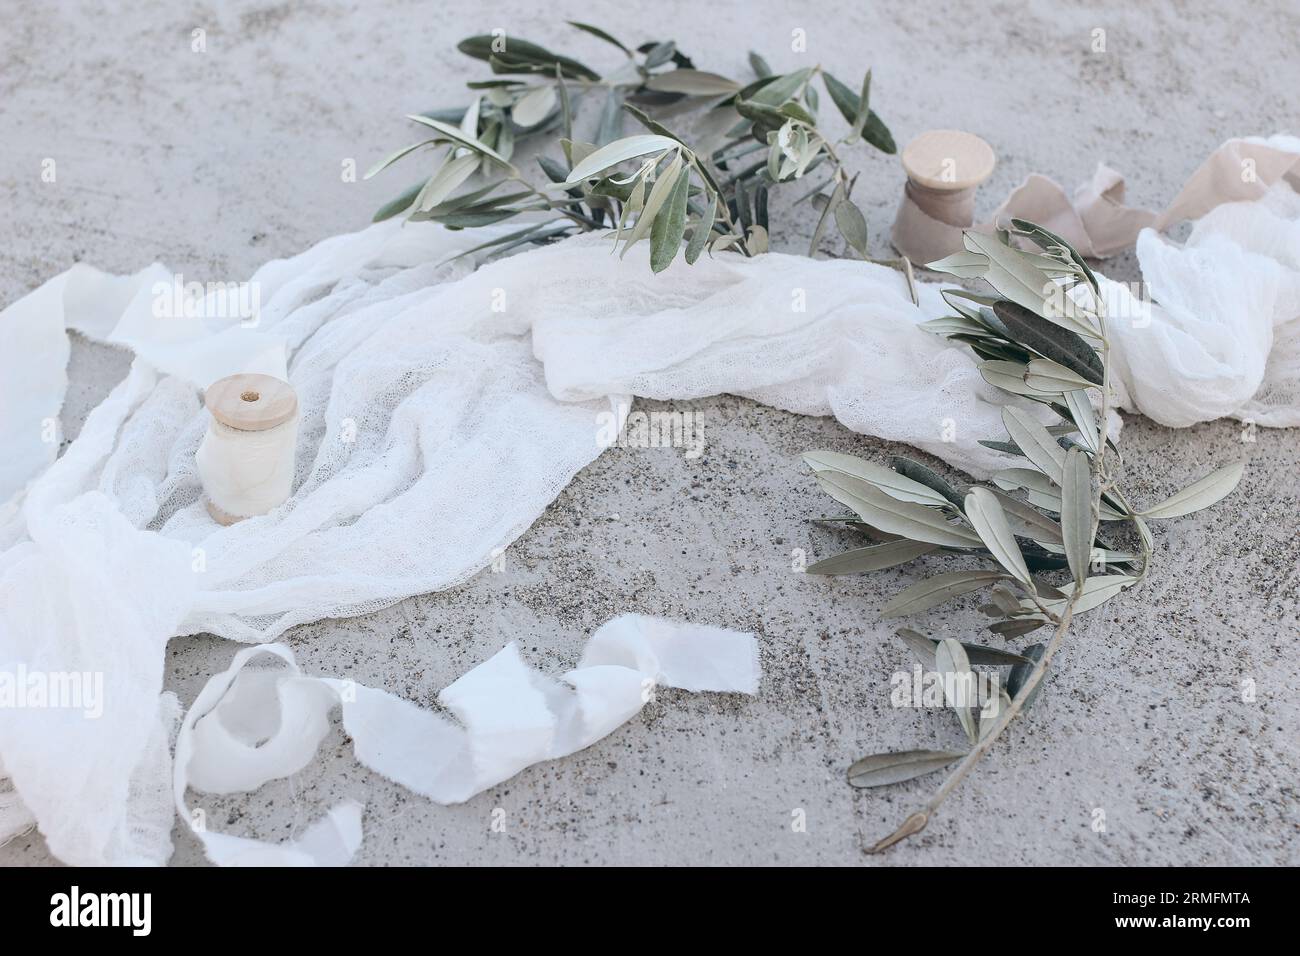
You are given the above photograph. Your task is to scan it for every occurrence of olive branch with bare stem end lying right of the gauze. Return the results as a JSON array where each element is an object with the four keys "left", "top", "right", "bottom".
[{"left": 805, "top": 219, "right": 1245, "bottom": 852}]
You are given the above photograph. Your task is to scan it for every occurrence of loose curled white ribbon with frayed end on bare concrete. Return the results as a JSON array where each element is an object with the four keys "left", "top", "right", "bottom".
[{"left": 173, "top": 614, "right": 759, "bottom": 866}]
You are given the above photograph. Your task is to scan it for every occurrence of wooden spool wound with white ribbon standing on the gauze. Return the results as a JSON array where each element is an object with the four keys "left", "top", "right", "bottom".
[{"left": 194, "top": 373, "right": 298, "bottom": 524}]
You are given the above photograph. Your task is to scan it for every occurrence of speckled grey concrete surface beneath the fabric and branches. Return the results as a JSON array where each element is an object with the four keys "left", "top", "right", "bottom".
[{"left": 0, "top": 0, "right": 1300, "bottom": 865}]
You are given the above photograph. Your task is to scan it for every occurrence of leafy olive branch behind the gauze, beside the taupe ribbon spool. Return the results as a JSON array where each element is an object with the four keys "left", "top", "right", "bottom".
[{"left": 365, "top": 21, "right": 910, "bottom": 273}]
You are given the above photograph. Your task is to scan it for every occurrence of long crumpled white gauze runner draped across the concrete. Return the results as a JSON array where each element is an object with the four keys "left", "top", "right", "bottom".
[{"left": 0, "top": 132, "right": 1300, "bottom": 864}]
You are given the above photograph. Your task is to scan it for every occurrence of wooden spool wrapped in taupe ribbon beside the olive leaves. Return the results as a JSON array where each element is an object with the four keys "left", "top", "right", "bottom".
[{"left": 892, "top": 130, "right": 997, "bottom": 265}]
